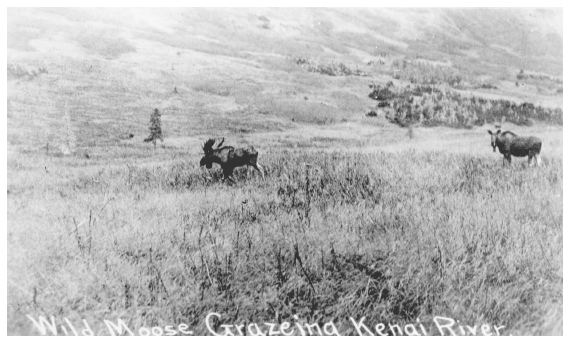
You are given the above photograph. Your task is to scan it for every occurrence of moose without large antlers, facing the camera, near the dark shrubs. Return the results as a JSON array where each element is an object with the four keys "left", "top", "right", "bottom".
[{"left": 487, "top": 130, "right": 542, "bottom": 166}]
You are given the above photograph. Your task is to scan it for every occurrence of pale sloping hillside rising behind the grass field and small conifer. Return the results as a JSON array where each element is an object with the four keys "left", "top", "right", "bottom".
[{"left": 8, "top": 9, "right": 562, "bottom": 155}]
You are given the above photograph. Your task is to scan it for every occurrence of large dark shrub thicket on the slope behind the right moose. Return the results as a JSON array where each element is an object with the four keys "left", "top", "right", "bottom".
[{"left": 369, "top": 82, "right": 563, "bottom": 128}]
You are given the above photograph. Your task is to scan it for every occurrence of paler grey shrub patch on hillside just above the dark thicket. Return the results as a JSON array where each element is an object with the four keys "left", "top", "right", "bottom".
[{"left": 392, "top": 59, "right": 497, "bottom": 89}]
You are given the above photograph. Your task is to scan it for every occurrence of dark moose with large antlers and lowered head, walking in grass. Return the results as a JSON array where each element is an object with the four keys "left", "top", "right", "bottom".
[{"left": 200, "top": 138, "right": 265, "bottom": 182}]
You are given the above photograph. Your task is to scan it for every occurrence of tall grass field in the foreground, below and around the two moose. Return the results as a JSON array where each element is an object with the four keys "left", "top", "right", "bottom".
[{"left": 8, "top": 151, "right": 563, "bottom": 334}]
